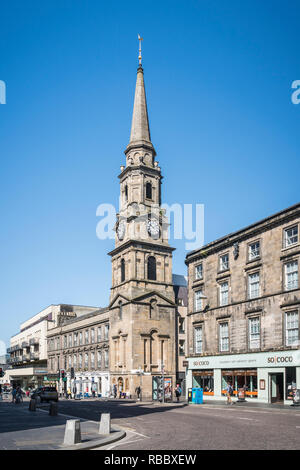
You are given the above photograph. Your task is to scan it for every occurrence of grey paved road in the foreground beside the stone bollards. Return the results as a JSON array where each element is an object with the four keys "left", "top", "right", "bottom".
[{"left": 39, "top": 400, "right": 300, "bottom": 450}]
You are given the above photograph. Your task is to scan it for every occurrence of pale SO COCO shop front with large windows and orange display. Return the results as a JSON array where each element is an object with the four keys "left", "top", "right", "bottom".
[{"left": 186, "top": 350, "right": 300, "bottom": 404}]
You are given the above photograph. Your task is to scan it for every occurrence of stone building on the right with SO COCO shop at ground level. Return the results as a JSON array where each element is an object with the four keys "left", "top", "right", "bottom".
[{"left": 186, "top": 204, "right": 300, "bottom": 403}]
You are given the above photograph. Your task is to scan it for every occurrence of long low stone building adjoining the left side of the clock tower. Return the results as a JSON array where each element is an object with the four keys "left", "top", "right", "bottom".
[{"left": 48, "top": 308, "right": 110, "bottom": 397}]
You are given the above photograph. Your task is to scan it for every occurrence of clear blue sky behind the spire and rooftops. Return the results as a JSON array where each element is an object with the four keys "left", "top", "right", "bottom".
[{"left": 0, "top": 0, "right": 300, "bottom": 342}]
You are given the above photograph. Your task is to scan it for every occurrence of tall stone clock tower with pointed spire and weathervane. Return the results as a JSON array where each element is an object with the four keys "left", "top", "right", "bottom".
[{"left": 109, "top": 42, "right": 176, "bottom": 399}]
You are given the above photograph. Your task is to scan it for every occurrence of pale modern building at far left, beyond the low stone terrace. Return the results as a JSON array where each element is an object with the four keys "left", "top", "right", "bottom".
[{"left": 6, "top": 304, "right": 96, "bottom": 389}]
